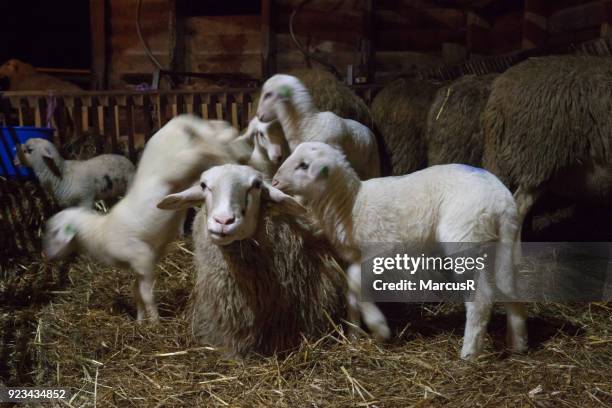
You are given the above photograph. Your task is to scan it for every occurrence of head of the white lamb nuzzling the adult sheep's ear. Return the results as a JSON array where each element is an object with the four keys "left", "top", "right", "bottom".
[{"left": 272, "top": 142, "right": 346, "bottom": 200}]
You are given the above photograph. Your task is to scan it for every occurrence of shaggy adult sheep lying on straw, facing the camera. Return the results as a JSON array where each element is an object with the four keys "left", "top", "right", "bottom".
[{"left": 158, "top": 164, "right": 346, "bottom": 356}]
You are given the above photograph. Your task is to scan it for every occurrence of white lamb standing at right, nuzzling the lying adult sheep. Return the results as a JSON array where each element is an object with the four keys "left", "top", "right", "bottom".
[{"left": 272, "top": 142, "right": 527, "bottom": 358}]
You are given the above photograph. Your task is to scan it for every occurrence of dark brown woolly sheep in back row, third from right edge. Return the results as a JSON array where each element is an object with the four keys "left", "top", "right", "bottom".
[{"left": 372, "top": 78, "right": 440, "bottom": 176}]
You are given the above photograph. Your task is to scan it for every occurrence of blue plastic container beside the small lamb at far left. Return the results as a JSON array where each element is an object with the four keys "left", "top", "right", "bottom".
[{"left": 0, "top": 126, "right": 55, "bottom": 178}]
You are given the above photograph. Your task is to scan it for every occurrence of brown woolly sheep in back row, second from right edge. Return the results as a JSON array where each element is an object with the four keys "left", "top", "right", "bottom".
[{"left": 427, "top": 75, "right": 497, "bottom": 167}]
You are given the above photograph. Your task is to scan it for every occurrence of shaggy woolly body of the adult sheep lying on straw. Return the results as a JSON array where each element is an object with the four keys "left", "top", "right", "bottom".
[{"left": 190, "top": 210, "right": 346, "bottom": 356}]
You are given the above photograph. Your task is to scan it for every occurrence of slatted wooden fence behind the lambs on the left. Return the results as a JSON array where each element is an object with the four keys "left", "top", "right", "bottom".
[{"left": 0, "top": 86, "right": 374, "bottom": 267}]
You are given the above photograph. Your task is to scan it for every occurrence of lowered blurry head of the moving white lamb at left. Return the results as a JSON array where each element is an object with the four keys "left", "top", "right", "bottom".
[{"left": 43, "top": 208, "right": 81, "bottom": 260}]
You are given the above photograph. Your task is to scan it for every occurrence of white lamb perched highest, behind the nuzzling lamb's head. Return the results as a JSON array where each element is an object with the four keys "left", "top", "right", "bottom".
[{"left": 257, "top": 74, "right": 380, "bottom": 179}]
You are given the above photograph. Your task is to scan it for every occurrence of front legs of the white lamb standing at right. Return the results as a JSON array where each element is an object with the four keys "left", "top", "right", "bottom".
[{"left": 347, "top": 264, "right": 391, "bottom": 340}]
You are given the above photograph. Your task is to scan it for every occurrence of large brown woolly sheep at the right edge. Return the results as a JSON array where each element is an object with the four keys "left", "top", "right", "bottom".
[{"left": 483, "top": 56, "right": 612, "bottom": 236}]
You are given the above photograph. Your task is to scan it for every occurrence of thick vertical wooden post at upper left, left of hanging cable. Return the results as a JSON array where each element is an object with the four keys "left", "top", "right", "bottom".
[{"left": 89, "top": 0, "right": 108, "bottom": 89}]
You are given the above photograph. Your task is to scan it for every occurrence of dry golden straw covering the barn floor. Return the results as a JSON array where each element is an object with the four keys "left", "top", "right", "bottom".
[{"left": 0, "top": 243, "right": 612, "bottom": 408}]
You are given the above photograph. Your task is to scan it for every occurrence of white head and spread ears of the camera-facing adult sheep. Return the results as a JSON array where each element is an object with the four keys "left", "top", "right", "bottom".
[{"left": 157, "top": 164, "right": 305, "bottom": 245}]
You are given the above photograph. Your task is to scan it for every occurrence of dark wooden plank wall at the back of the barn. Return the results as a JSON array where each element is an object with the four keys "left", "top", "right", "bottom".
[{"left": 109, "top": 0, "right": 611, "bottom": 87}]
